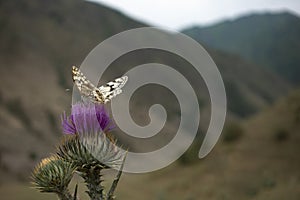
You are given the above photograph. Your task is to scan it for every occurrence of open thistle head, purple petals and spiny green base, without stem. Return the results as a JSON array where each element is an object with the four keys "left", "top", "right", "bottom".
[{"left": 60, "top": 102, "right": 126, "bottom": 169}]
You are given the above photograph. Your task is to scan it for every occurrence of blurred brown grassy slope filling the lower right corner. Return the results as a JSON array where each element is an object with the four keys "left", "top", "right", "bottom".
[{"left": 112, "top": 90, "right": 300, "bottom": 200}]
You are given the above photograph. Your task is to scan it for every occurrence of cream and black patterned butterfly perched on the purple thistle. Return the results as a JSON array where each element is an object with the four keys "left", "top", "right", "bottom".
[{"left": 72, "top": 66, "right": 128, "bottom": 104}]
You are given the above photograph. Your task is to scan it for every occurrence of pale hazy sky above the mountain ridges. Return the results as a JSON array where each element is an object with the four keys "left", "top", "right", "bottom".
[{"left": 89, "top": 0, "right": 300, "bottom": 30}]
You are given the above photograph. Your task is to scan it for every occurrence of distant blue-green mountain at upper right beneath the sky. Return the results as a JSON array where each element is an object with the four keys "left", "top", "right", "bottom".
[{"left": 182, "top": 12, "right": 300, "bottom": 84}]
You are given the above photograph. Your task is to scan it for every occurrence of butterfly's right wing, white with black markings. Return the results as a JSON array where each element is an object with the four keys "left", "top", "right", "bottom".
[{"left": 98, "top": 76, "right": 128, "bottom": 103}]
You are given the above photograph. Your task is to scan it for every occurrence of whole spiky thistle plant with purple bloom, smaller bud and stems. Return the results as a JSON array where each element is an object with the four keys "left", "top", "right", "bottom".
[{"left": 33, "top": 103, "right": 126, "bottom": 200}]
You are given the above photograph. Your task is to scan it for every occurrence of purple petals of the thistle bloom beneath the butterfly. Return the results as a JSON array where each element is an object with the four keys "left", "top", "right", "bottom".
[{"left": 62, "top": 103, "right": 114, "bottom": 135}]
